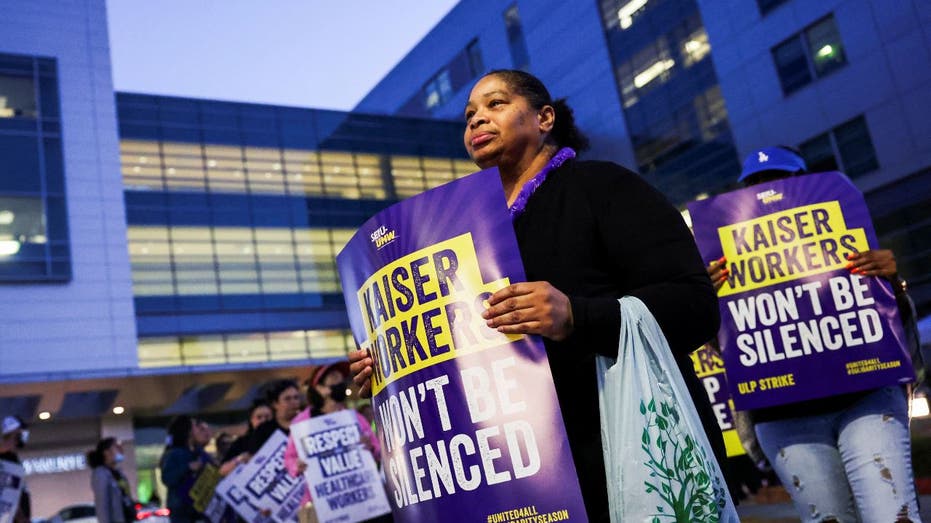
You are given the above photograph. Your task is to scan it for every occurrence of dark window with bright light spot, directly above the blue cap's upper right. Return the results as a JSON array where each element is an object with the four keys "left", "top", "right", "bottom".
[{"left": 772, "top": 15, "right": 847, "bottom": 95}]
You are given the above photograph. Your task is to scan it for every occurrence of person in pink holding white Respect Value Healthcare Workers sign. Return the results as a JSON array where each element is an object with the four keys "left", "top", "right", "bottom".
[{"left": 284, "top": 361, "right": 381, "bottom": 505}]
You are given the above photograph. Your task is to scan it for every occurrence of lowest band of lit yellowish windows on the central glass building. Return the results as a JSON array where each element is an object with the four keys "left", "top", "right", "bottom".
[{"left": 139, "top": 329, "right": 355, "bottom": 368}]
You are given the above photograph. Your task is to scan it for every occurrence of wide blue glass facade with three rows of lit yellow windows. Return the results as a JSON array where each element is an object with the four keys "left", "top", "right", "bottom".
[{"left": 117, "top": 94, "right": 477, "bottom": 367}]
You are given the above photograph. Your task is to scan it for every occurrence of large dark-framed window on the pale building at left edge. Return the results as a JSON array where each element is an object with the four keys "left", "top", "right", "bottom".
[{"left": 0, "top": 54, "right": 71, "bottom": 281}]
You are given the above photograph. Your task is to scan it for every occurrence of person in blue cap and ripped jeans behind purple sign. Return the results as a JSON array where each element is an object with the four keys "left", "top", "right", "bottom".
[{"left": 707, "top": 146, "right": 924, "bottom": 523}]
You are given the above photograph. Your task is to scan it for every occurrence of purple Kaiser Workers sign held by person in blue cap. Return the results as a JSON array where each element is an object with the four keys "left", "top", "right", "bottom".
[{"left": 689, "top": 172, "right": 914, "bottom": 410}]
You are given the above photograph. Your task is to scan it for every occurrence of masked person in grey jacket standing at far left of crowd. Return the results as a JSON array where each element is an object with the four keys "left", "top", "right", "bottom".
[{"left": 87, "top": 438, "right": 136, "bottom": 523}]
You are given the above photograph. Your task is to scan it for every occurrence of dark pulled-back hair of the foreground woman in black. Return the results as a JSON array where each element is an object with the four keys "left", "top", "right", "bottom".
[{"left": 485, "top": 69, "right": 589, "bottom": 152}]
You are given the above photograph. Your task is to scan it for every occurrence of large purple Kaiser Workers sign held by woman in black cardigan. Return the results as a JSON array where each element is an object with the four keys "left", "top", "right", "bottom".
[{"left": 337, "top": 169, "right": 586, "bottom": 522}]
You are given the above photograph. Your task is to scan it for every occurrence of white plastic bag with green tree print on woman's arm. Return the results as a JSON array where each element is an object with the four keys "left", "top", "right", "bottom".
[{"left": 598, "top": 296, "right": 739, "bottom": 523}]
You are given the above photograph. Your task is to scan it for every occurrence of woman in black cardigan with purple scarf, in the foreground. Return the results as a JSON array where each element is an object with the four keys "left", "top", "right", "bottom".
[{"left": 350, "top": 71, "right": 724, "bottom": 522}]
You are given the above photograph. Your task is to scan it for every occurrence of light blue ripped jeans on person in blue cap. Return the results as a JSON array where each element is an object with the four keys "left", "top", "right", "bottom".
[{"left": 756, "top": 386, "right": 921, "bottom": 523}]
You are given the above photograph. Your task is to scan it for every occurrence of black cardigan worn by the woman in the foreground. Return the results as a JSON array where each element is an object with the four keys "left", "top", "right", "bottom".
[{"left": 514, "top": 161, "right": 724, "bottom": 522}]
